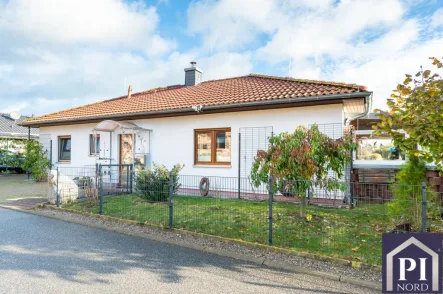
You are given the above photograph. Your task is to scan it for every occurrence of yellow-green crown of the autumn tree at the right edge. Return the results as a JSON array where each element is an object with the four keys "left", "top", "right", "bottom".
[{"left": 374, "top": 57, "right": 443, "bottom": 170}]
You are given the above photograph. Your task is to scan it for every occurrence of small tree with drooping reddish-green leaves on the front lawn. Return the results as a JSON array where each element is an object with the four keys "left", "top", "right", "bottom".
[{"left": 251, "top": 125, "right": 355, "bottom": 217}]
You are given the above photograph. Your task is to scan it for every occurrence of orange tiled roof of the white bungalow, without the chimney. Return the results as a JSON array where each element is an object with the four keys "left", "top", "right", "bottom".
[{"left": 23, "top": 74, "right": 367, "bottom": 124}]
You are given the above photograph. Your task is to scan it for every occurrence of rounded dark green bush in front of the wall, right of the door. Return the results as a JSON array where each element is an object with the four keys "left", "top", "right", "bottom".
[{"left": 134, "top": 163, "right": 184, "bottom": 202}]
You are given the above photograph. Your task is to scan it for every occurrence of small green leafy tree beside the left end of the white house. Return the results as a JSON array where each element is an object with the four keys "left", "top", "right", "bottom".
[{"left": 24, "top": 140, "right": 50, "bottom": 181}]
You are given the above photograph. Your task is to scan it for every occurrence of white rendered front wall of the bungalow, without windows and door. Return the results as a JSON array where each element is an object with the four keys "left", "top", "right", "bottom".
[{"left": 40, "top": 104, "right": 344, "bottom": 177}]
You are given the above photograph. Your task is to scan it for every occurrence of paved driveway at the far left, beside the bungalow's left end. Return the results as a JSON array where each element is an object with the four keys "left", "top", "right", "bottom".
[{"left": 0, "top": 173, "right": 48, "bottom": 203}]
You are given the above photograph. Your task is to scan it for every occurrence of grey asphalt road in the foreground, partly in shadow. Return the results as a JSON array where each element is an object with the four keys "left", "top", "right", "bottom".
[{"left": 0, "top": 209, "right": 377, "bottom": 294}]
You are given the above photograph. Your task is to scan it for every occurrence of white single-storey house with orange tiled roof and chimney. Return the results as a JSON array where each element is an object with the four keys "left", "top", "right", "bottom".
[{"left": 23, "top": 63, "right": 372, "bottom": 177}]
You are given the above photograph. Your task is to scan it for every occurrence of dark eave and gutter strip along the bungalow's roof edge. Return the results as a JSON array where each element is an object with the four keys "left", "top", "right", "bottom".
[{"left": 21, "top": 91, "right": 372, "bottom": 127}]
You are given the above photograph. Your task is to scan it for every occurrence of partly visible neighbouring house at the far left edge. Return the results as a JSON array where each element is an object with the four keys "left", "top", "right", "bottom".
[{"left": 0, "top": 113, "right": 39, "bottom": 152}]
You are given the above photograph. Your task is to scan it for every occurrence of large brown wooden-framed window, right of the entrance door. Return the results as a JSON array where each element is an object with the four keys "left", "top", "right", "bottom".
[{"left": 194, "top": 128, "right": 231, "bottom": 165}]
